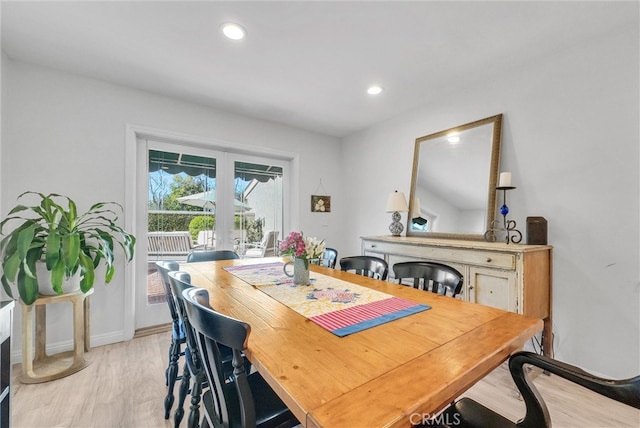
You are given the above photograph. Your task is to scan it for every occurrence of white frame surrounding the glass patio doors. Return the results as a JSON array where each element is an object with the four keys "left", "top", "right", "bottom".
[{"left": 123, "top": 123, "right": 300, "bottom": 340}]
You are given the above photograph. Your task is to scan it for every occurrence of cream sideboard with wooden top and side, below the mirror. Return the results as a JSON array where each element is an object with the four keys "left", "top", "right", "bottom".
[{"left": 362, "top": 236, "right": 553, "bottom": 356}]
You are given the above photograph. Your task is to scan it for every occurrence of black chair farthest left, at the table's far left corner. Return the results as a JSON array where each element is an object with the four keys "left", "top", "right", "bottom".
[{"left": 156, "top": 261, "right": 187, "bottom": 419}]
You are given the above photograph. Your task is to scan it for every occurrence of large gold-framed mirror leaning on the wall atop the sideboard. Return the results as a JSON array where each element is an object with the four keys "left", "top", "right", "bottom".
[{"left": 407, "top": 114, "right": 502, "bottom": 240}]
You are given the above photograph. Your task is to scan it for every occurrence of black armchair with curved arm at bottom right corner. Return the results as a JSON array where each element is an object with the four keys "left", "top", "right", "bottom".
[{"left": 422, "top": 351, "right": 640, "bottom": 428}]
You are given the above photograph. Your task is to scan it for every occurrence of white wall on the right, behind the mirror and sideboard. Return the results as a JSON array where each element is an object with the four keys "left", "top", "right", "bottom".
[{"left": 343, "top": 24, "right": 640, "bottom": 377}]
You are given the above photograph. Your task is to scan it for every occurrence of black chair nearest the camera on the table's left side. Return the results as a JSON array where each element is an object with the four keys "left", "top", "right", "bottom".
[{"left": 183, "top": 287, "right": 299, "bottom": 428}]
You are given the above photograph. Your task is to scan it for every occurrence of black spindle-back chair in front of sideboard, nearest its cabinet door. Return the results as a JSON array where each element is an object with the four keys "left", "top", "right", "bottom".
[{"left": 393, "top": 261, "right": 464, "bottom": 296}]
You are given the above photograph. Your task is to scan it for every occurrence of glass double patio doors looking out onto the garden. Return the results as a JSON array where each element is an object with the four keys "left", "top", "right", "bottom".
[{"left": 135, "top": 139, "right": 288, "bottom": 329}]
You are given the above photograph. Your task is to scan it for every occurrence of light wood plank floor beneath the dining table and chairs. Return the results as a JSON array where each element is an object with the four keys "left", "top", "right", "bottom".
[{"left": 11, "top": 332, "right": 640, "bottom": 428}]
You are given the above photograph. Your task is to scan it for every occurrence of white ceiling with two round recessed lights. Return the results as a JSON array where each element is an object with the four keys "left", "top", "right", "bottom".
[{"left": 2, "top": 1, "right": 638, "bottom": 137}]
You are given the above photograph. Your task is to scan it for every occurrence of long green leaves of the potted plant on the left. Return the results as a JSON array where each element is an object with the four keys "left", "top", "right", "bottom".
[{"left": 0, "top": 191, "right": 136, "bottom": 305}]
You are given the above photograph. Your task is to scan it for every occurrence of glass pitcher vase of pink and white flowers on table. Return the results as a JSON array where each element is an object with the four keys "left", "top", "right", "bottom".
[{"left": 280, "top": 232, "right": 324, "bottom": 285}]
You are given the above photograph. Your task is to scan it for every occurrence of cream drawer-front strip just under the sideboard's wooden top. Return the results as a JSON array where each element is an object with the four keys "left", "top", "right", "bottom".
[{"left": 363, "top": 240, "right": 516, "bottom": 270}]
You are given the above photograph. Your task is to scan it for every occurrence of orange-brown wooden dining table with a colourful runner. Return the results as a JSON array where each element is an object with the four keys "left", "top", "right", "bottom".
[{"left": 180, "top": 258, "right": 543, "bottom": 428}]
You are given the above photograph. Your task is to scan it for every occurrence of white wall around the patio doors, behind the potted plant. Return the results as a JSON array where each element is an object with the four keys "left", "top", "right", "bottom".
[{"left": 0, "top": 57, "right": 344, "bottom": 351}]
